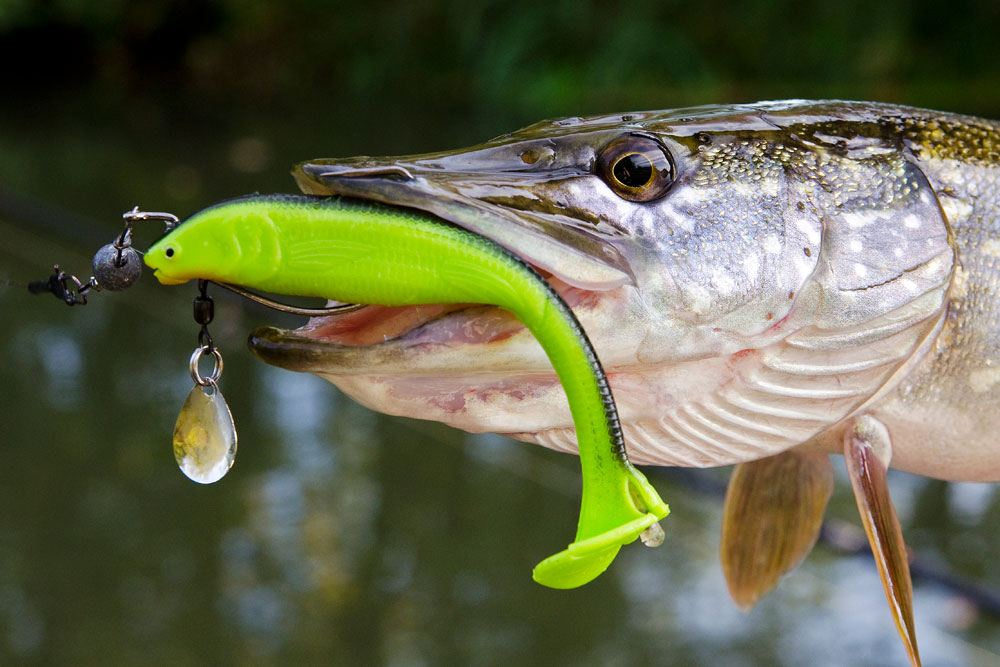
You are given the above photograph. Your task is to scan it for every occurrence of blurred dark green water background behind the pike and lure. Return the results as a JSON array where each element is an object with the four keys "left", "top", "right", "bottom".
[{"left": 0, "top": 0, "right": 1000, "bottom": 667}]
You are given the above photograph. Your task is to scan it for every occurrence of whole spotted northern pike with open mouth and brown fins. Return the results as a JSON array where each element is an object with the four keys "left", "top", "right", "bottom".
[{"left": 225, "top": 100, "right": 1000, "bottom": 664}]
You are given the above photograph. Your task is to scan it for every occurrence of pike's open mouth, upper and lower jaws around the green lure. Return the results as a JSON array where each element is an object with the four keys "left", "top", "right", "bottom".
[{"left": 249, "top": 149, "right": 633, "bottom": 439}]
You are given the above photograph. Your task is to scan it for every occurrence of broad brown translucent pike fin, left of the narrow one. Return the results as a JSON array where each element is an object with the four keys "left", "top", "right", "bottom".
[{"left": 721, "top": 450, "right": 833, "bottom": 609}]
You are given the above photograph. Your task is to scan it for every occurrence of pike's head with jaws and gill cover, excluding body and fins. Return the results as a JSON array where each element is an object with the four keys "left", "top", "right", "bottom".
[{"left": 251, "top": 102, "right": 953, "bottom": 466}]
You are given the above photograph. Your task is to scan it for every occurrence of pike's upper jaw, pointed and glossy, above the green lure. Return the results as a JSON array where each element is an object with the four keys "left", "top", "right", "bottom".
[{"left": 292, "top": 147, "right": 634, "bottom": 290}]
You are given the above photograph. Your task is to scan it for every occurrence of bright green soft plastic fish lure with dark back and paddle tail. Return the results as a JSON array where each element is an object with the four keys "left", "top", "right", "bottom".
[{"left": 145, "top": 195, "right": 669, "bottom": 588}]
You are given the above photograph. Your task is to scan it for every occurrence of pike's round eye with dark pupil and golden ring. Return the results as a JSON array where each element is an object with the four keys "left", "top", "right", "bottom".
[{"left": 595, "top": 134, "right": 674, "bottom": 202}]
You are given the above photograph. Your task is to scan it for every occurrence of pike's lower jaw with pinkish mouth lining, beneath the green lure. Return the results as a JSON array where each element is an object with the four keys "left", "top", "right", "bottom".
[{"left": 249, "top": 276, "right": 613, "bottom": 441}]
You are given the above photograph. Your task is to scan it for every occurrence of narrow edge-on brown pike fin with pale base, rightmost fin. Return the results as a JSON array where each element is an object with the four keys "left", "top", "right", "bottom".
[{"left": 844, "top": 415, "right": 920, "bottom": 667}]
